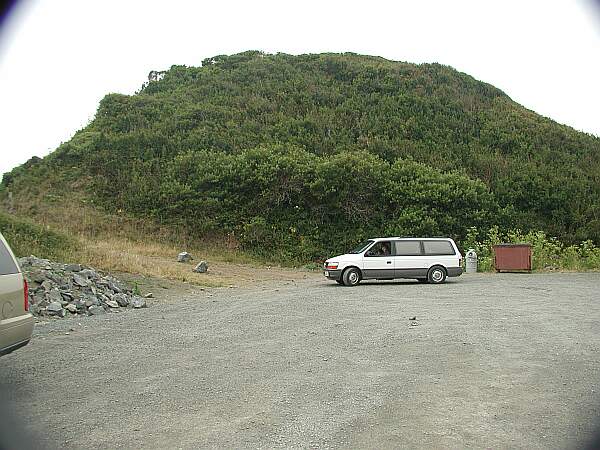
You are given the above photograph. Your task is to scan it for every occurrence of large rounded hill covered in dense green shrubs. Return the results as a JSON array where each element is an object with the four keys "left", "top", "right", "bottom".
[{"left": 3, "top": 52, "right": 600, "bottom": 261}]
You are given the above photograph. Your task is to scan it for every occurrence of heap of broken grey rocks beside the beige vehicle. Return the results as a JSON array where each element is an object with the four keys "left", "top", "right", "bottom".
[{"left": 19, "top": 256, "right": 146, "bottom": 317}]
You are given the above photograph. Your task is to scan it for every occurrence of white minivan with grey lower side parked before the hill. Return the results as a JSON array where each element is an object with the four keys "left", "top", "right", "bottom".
[{"left": 323, "top": 237, "right": 462, "bottom": 286}]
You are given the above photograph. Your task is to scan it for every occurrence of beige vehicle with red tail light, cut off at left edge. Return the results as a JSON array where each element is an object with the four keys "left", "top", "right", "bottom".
[{"left": 0, "top": 233, "right": 34, "bottom": 355}]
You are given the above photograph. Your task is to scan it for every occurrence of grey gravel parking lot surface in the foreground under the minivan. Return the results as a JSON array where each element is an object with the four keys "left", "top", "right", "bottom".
[{"left": 0, "top": 273, "right": 600, "bottom": 449}]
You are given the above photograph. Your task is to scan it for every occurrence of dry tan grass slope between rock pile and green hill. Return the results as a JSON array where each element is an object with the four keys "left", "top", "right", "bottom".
[{"left": 0, "top": 198, "right": 306, "bottom": 287}]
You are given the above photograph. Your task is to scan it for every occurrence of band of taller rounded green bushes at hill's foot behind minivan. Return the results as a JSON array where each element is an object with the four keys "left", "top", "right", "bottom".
[{"left": 102, "top": 146, "right": 497, "bottom": 261}]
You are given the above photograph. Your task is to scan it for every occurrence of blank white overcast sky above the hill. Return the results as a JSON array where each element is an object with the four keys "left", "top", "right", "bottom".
[{"left": 0, "top": 0, "right": 600, "bottom": 178}]
